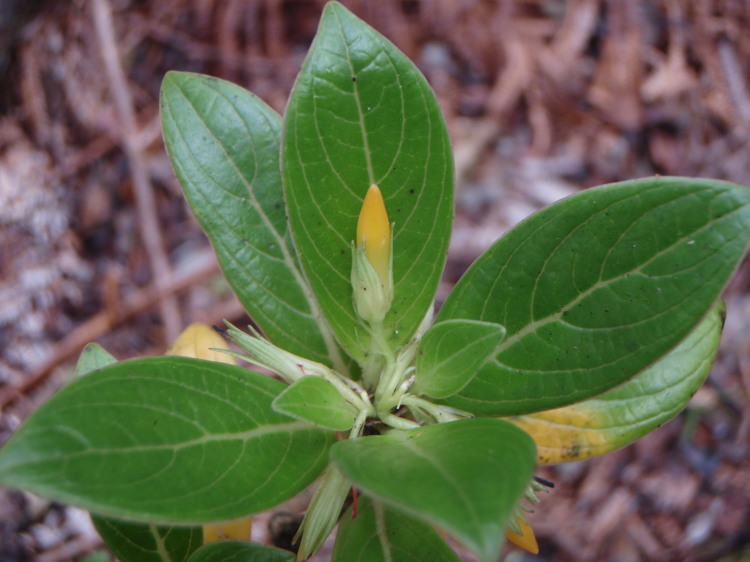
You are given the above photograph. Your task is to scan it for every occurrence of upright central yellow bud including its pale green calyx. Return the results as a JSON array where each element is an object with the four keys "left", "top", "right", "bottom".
[{"left": 352, "top": 184, "right": 393, "bottom": 324}]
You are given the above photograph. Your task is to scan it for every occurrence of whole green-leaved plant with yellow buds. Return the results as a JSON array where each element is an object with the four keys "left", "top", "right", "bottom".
[{"left": 0, "top": 3, "right": 750, "bottom": 562}]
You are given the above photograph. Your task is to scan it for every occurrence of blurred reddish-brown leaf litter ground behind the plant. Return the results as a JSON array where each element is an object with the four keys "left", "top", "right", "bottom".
[{"left": 0, "top": 0, "right": 750, "bottom": 562}]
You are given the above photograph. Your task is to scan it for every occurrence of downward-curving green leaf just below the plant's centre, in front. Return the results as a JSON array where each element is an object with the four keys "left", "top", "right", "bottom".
[{"left": 331, "top": 418, "right": 536, "bottom": 560}]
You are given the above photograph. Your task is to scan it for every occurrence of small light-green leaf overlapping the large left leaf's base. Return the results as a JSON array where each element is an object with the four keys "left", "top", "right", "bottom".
[{"left": 273, "top": 376, "right": 357, "bottom": 431}]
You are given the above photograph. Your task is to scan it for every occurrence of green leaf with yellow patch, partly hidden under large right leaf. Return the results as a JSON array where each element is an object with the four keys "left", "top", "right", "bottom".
[{"left": 508, "top": 305, "right": 724, "bottom": 464}]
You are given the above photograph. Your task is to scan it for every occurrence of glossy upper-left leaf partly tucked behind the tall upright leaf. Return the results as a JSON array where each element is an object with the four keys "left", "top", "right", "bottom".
[{"left": 161, "top": 72, "right": 346, "bottom": 372}]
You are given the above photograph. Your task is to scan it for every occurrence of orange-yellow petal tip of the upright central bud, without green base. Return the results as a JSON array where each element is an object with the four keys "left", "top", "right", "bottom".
[{"left": 357, "top": 184, "right": 391, "bottom": 286}]
